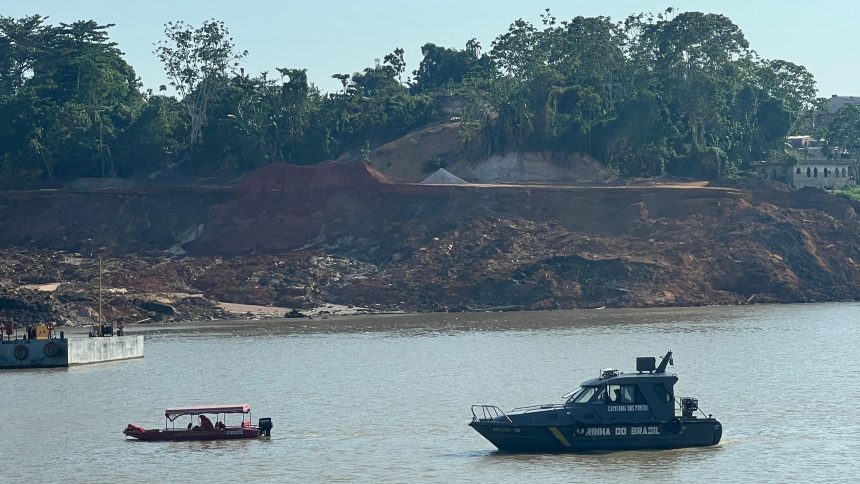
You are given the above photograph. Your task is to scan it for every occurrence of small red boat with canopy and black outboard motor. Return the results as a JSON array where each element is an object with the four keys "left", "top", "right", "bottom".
[{"left": 122, "top": 403, "right": 272, "bottom": 441}]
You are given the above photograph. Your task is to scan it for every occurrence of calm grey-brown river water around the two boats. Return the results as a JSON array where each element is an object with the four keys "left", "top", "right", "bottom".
[{"left": 0, "top": 303, "right": 860, "bottom": 483}]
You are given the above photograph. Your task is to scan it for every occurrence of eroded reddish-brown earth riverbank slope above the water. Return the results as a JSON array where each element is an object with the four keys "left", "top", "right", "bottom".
[{"left": 0, "top": 162, "right": 860, "bottom": 322}]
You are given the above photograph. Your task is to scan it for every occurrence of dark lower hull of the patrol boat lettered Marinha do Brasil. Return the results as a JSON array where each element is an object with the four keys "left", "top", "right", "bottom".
[{"left": 469, "top": 419, "right": 722, "bottom": 452}]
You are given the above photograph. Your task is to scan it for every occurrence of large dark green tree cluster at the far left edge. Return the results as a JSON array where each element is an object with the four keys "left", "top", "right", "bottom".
[{"left": 0, "top": 16, "right": 143, "bottom": 179}]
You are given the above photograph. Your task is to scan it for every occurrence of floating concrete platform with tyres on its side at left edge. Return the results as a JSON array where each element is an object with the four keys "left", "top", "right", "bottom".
[{"left": 0, "top": 335, "right": 143, "bottom": 369}]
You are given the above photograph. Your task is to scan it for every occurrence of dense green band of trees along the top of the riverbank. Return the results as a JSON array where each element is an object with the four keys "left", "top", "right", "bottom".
[{"left": 0, "top": 9, "right": 848, "bottom": 182}]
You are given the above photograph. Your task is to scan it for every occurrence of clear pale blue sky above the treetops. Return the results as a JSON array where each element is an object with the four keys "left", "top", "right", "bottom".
[{"left": 6, "top": 0, "right": 860, "bottom": 97}]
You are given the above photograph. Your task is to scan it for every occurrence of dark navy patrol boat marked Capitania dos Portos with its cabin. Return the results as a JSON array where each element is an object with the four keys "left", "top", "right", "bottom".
[{"left": 469, "top": 351, "right": 723, "bottom": 452}]
